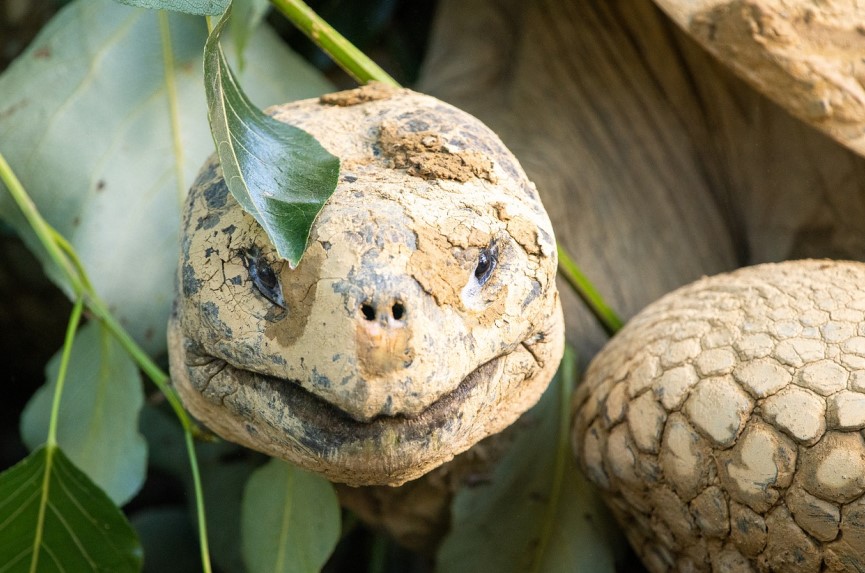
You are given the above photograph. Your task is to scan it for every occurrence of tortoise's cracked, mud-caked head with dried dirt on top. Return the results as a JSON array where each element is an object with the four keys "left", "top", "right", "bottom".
[{"left": 169, "top": 85, "right": 564, "bottom": 485}]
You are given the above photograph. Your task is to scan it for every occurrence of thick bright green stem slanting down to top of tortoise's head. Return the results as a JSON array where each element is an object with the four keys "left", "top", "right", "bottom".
[{"left": 270, "top": 0, "right": 399, "bottom": 87}]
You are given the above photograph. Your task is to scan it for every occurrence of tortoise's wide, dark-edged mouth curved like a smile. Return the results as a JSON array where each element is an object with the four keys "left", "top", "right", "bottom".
[{"left": 187, "top": 342, "right": 510, "bottom": 457}]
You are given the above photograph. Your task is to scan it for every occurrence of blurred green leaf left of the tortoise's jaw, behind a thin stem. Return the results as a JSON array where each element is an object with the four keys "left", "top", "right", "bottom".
[{"left": 21, "top": 322, "right": 147, "bottom": 505}]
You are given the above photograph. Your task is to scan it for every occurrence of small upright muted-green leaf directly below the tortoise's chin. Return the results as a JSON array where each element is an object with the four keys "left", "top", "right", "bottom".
[{"left": 241, "top": 459, "right": 340, "bottom": 573}]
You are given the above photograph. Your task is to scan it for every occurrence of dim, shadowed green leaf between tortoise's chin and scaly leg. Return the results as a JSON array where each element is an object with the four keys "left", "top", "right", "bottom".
[{"left": 438, "top": 350, "right": 616, "bottom": 573}]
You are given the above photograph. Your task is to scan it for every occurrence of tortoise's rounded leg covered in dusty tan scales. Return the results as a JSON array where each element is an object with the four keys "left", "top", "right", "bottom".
[{"left": 573, "top": 260, "right": 865, "bottom": 573}]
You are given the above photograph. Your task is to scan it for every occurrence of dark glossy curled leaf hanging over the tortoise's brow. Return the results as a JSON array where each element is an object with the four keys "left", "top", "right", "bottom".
[{"left": 204, "top": 6, "right": 339, "bottom": 267}]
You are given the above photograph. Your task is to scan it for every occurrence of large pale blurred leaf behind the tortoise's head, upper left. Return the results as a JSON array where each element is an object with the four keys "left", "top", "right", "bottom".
[{"left": 0, "top": 0, "right": 329, "bottom": 354}]
